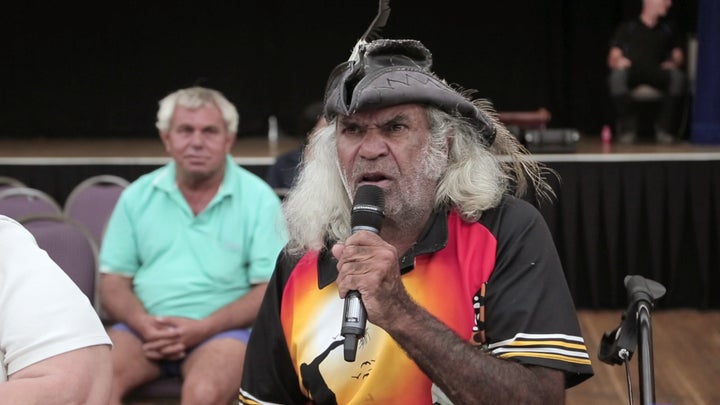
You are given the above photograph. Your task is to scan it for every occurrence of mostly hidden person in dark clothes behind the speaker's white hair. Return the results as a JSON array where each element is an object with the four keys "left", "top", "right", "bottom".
[{"left": 265, "top": 101, "right": 324, "bottom": 195}]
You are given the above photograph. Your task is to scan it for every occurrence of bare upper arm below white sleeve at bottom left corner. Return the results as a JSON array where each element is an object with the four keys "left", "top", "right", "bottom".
[{"left": 0, "top": 345, "right": 112, "bottom": 405}]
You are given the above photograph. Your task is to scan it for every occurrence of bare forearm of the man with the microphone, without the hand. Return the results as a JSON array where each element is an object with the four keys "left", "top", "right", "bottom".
[{"left": 383, "top": 294, "right": 565, "bottom": 405}]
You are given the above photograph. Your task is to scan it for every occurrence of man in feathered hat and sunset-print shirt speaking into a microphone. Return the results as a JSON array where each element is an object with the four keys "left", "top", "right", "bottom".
[{"left": 240, "top": 39, "right": 592, "bottom": 404}]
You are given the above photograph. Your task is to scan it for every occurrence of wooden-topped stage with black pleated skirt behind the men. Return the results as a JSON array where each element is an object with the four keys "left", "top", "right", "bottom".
[{"left": 0, "top": 137, "right": 720, "bottom": 309}]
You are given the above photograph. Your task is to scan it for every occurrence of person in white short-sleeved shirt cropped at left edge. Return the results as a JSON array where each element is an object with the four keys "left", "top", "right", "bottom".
[{"left": 0, "top": 215, "right": 112, "bottom": 405}]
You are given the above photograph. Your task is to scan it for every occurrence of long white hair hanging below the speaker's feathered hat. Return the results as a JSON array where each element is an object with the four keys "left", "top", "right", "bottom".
[{"left": 283, "top": 101, "right": 552, "bottom": 255}]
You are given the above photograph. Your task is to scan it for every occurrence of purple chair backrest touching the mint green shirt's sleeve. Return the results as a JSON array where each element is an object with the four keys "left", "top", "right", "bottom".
[{"left": 63, "top": 175, "right": 130, "bottom": 246}]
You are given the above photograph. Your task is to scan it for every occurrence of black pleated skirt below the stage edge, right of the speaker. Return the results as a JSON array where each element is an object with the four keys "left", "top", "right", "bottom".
[{"left": 540, "top": 160, "right": 720, "bottom": 309}]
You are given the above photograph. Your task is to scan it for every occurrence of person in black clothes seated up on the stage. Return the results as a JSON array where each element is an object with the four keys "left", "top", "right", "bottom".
[{"left": 607, "top": 0, "right": 686, "bottom": 143}]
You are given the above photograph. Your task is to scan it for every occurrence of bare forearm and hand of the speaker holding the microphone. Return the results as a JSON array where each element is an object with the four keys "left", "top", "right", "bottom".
[{"left": 333, "top": 232, "right": 565, "bottom": 404}]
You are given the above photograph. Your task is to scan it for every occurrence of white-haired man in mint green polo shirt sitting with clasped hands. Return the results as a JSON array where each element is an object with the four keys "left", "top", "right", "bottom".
[{"left": 100, "top": 87, "right": 287, "bottom": 404}]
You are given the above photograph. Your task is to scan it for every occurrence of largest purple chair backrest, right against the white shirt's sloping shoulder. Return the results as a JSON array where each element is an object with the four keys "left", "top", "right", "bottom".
[{"left": 18, "top": 214, "right": 100, "bottom": 313}]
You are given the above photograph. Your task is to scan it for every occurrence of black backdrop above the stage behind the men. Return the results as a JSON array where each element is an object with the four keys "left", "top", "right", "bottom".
[{"left": 0, "top": 0, "right": 697, "bottom": 138}]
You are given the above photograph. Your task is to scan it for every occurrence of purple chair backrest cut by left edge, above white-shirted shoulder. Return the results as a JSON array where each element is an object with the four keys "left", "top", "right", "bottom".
[{"left": 0, "top": 187, "right": 62, "bottom": 221}]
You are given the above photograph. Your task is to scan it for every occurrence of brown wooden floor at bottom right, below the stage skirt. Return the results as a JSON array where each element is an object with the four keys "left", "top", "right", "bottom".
[{"left": 567, "top": 309, "right": 720, "bottom": 405}]
